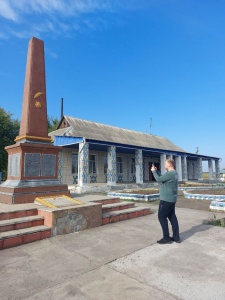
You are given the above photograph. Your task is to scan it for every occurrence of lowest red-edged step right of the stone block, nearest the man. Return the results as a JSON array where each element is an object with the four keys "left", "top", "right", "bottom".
[{"left": 102, "top": 206, "right": 151, "bottom": 225}]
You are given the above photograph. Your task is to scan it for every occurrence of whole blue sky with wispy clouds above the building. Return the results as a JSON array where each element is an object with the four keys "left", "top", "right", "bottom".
[{"left": 0, "top": 0, "right": 225, "bottom": 168}]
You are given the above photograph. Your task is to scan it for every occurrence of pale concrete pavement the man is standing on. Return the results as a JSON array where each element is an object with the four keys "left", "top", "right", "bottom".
[{"left": 0, "top": 204, "right": 225, "bottom": 300}]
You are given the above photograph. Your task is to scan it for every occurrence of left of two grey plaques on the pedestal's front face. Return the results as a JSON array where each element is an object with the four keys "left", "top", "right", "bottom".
[{"left": 24, "top": 153, "right": 41, "bottom": 177}]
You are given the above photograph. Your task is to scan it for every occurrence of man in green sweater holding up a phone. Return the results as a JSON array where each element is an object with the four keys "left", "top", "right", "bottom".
[{"left": 151, "top": 159, "right": 180, "bottom": 244}]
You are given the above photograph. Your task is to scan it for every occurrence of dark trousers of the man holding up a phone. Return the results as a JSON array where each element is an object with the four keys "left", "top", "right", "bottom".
[{"left": 158, "top": 200, "right": 180, "bottom": 241}]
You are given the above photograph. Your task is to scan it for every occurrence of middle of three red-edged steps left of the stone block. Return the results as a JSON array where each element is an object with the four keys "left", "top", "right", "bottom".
[{"left": 0, "top": 216, "right": 44, "bottom": 232}]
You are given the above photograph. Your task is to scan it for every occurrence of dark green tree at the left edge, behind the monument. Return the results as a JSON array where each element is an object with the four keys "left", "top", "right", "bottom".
[{"left": 0, "top": 108, "right": 20, "bottom": 180}]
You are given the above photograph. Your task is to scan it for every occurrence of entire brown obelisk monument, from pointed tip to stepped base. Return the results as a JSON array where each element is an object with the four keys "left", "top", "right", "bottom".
[{"left": 0, "top": 37, "right": 70, "bottom": 204}]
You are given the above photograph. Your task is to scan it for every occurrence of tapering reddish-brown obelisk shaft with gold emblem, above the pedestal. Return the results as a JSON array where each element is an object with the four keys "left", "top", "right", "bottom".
[{"left": 16, "top": 37, "right": 51, "bottom": 142}]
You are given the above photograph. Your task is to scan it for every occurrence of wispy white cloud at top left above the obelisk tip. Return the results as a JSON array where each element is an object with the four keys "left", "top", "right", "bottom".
[{"left": 0, "top": 0, "right": 124, "bottom": 39}]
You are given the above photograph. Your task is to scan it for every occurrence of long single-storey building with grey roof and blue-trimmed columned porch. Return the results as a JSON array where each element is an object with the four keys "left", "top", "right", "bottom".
[{"left": 50, "top": 116, "right": 220, "bottom": 187}]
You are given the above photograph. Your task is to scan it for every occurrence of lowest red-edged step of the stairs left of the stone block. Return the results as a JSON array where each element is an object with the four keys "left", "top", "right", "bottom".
[{"left": 0, "top": 225, "right": 51, "bottom": 250}]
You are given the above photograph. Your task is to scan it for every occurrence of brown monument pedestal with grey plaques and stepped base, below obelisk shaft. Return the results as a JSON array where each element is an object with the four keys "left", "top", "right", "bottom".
[{"left": 0, "top": 142, "right": 70, "bottom": 204}]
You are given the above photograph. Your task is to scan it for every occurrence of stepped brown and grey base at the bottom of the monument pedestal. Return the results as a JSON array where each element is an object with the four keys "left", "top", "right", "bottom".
[{"left": 0, "top": 180, "right": 71, "bottom": 204}]
